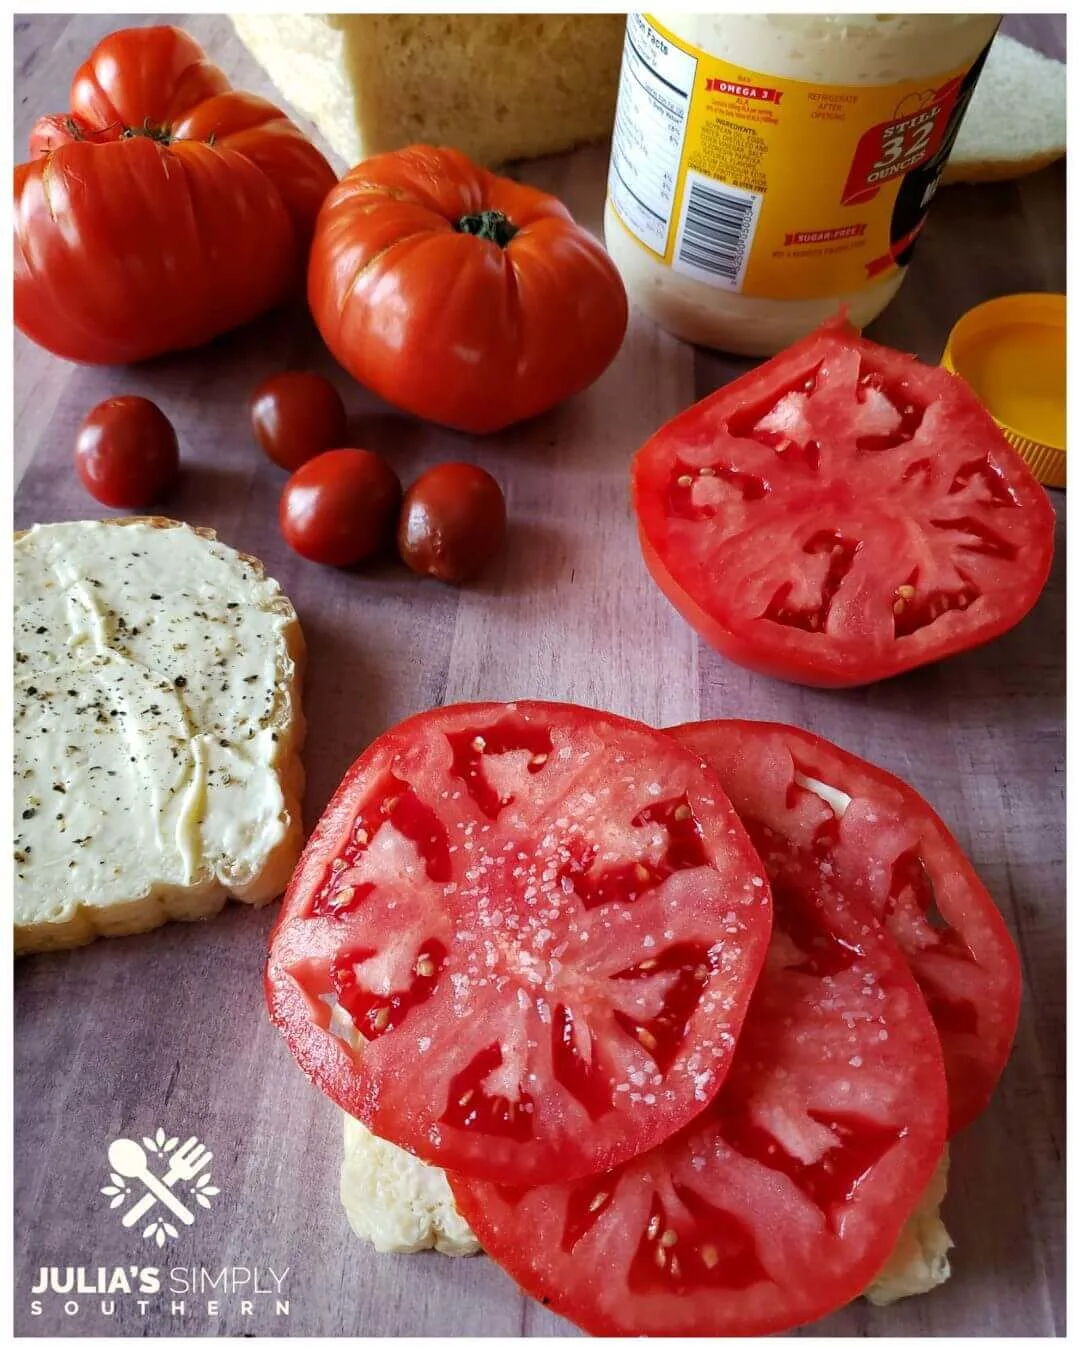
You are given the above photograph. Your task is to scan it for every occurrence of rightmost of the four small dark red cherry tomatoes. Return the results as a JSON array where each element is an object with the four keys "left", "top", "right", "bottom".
[{"left": 397, "top": 463, "right": 507, "bottom": 584}]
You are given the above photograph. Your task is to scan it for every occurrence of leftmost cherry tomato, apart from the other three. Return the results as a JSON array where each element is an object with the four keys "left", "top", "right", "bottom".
[{"left": 74, "top": 394, "right": 180, "bottom": 508}]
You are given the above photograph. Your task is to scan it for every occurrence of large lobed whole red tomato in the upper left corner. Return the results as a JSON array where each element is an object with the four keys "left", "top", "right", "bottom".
[{"left": 15, "top": 27, "right": 335, "bottom": 363}]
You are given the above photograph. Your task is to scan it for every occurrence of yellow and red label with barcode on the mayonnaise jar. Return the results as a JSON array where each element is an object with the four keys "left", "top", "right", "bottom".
[{"left": 608, "top": 14, "right": 984, "bottom": 300}]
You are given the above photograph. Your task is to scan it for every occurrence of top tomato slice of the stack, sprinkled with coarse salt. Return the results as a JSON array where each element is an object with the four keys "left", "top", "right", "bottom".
[{"left": 266, "top": 703, "right": 770, "bottom": 1182}]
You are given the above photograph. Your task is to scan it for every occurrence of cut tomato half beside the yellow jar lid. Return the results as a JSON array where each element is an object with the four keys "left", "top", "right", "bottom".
[{"left": 634, "top": 322, "right": 1054, "bottom": 686}]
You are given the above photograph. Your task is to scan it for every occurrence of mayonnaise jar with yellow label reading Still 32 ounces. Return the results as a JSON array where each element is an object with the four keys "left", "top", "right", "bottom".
[{"left": 604, "top": 14, "right": 999, "bottom": 357}]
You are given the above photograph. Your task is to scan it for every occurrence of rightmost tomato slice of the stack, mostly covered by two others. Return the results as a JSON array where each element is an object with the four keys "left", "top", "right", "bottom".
[{"left": 673, "top": 721, "right": 1021, "bottom": 1133}]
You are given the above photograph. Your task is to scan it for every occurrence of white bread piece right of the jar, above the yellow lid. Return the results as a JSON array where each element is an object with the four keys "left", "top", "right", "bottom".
[{"left": 942, "top": 34, "right": 1065, "bottom": 182}]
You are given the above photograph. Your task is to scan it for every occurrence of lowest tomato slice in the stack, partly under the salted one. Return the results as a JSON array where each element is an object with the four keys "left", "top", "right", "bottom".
[{"left": 450, "top": 788, "right": 946, "bottom": 1336}]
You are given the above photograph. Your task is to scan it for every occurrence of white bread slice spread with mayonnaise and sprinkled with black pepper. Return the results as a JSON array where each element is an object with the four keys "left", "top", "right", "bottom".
[{"left": 14, "top": 517, "right": 304, "bottom": 954}]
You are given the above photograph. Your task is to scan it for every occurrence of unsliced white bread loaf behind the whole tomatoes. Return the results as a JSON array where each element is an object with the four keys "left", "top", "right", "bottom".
[{"left": 231, "top": 14, "right": 626, "bottom": 168}]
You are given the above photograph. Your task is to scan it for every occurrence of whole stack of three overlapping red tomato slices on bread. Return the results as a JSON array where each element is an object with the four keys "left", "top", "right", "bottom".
[{"left": 266, "top": 703, "right": 1019, "bottom": 1335}]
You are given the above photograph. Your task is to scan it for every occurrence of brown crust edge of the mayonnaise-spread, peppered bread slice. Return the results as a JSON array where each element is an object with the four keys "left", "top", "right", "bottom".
[{"left": 15, "top": 516, "right": 307, "bottom": 957}]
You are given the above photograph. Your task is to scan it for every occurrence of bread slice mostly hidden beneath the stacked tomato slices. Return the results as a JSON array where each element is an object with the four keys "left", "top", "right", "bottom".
[{"left": 341, "top": 1113, "right": 952, "bottom": 1305}]
